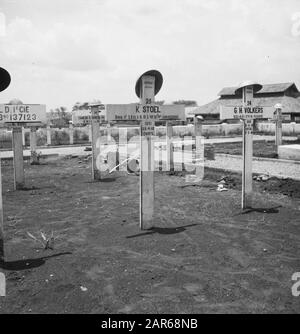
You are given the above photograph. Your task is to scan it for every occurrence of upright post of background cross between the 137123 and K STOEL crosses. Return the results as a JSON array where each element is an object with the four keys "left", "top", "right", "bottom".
[{"left": 90, "top": 106, "right": 101, "bottom": 180}]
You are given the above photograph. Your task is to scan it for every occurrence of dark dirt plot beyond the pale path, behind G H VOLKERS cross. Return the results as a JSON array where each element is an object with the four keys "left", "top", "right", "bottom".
[{"left": 214, "top": 140, "right": 300, "bottom": 159}]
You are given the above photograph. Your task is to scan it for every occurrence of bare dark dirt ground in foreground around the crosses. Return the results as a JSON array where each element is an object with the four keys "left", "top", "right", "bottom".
[{"left": 0, "top": 158, "right": 300, "bottom": 314}]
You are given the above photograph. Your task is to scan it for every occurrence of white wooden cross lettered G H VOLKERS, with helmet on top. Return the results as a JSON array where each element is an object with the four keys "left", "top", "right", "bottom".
[{"left": 220, "top": 81, "right": 274, "bottom": 209}]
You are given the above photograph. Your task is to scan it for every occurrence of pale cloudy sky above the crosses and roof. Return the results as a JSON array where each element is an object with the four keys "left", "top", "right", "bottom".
[{"left": 0, "top": 0, "right": 300, "bottom": 111}]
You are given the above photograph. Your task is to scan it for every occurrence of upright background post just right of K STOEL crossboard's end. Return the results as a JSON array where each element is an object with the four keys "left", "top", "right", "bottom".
[{"left": 194, "top": 115, "right": 204, "bottom": 182}]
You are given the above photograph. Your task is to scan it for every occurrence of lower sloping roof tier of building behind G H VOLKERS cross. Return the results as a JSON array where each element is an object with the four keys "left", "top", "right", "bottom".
[{"left": 189, "top": 96, "right": 300, "bottom": 116}]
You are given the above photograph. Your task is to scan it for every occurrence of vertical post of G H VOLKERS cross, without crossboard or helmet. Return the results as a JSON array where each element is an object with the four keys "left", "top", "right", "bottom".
[{"left": 242, "top": 86, "right": 253, "bottom": 210}]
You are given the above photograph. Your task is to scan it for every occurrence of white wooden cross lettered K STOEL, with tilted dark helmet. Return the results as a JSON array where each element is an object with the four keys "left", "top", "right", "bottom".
[{"left": 92, "top": 70, "right": 185, "bottom": 230}]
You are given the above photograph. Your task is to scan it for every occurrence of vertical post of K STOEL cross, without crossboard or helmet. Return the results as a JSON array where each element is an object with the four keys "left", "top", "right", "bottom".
[{"left": 140, "top": 75, "right": 155, "bottom": 230}]
